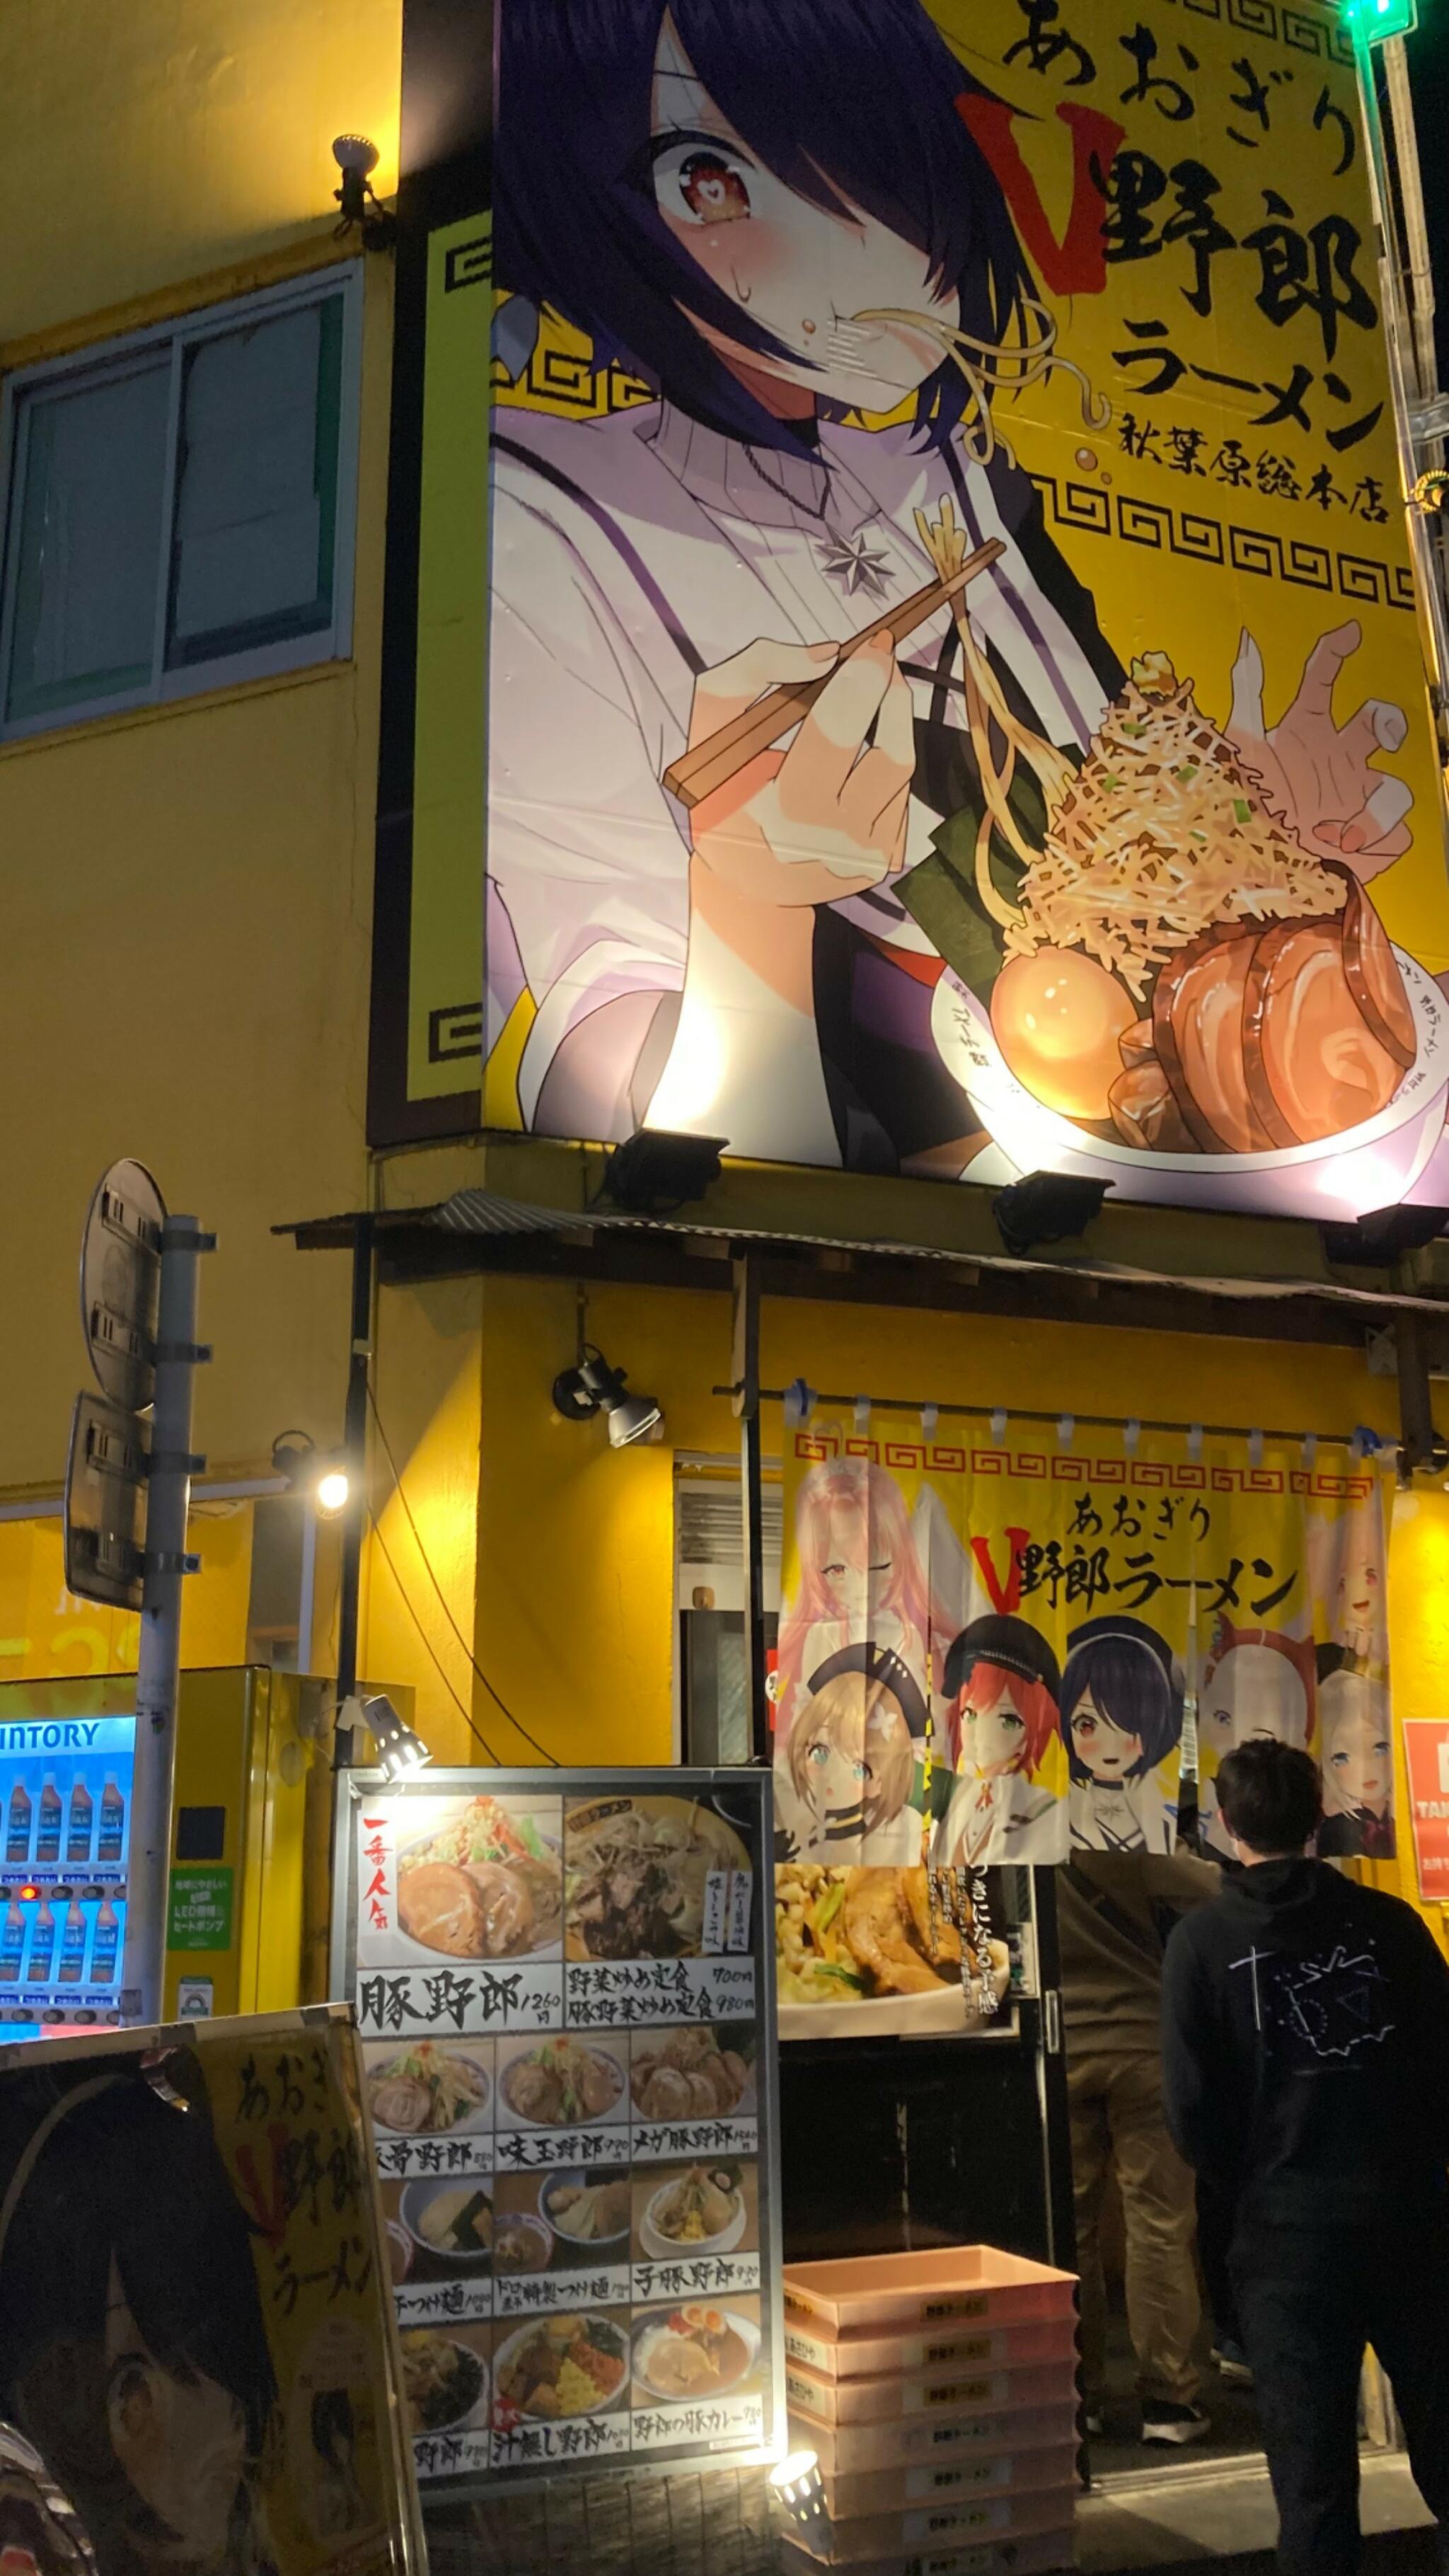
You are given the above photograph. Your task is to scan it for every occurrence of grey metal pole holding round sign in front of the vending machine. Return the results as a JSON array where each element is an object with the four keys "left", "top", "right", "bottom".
[{"left": 121, "top": 1216, "right": 217, "bottom": 2022}]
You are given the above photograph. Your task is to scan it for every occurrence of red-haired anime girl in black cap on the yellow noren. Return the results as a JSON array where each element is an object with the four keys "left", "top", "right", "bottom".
[{"left": 933, "top": 1612, "right": 1068, "bottom": 1868}]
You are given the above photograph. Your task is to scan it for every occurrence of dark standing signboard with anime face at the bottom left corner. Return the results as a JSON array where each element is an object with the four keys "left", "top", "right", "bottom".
[{"left": 0, "top": 2004, "right": 425, "bottom": 2576}]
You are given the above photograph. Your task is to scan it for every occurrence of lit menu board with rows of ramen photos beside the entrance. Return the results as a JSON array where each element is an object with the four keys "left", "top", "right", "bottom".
[{"left": 333, "top": 1769, "right": 784, "bottom": 2493}]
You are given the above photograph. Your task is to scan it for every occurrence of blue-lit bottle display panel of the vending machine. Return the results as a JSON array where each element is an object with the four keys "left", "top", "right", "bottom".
[{"left": 0, "top": 1716, "right": 137, "bottom": 2040}]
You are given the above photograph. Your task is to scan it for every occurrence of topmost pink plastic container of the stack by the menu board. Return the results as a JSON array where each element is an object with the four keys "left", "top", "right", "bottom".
[{"left": 784, "top": 2246, "right": 1075, "bottom": 2336}]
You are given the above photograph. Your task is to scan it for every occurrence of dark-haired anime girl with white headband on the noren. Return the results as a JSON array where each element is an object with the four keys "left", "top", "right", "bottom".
[{"left": 1060, "top": 1612, "right": 1184, "bottom": 1852}]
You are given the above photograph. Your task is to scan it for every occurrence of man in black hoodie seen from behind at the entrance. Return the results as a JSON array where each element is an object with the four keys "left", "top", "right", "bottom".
[{"left": 1163, "top": 1739, "right": 1449, "bottom": 2576}]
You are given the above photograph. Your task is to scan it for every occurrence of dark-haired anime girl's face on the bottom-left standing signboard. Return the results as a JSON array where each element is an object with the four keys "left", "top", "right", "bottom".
[{"left": 0, "top": 2066, "right": 279, "bottom": 2576}]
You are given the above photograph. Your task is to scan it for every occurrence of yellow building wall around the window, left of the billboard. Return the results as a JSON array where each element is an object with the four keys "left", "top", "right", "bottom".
[{"left": 0, "top": 0, "right": 402, "bottom": 1525}]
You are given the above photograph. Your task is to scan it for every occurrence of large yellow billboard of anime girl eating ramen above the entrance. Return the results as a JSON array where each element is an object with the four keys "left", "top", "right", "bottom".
[{"left": 391, "top": 0, "right": 1449, "bottom": 1213}]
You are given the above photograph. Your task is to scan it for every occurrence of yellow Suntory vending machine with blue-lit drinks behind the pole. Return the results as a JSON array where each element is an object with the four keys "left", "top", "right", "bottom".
[{"left": 0, "top": 1664, "right": 313, "bottom": 2040}]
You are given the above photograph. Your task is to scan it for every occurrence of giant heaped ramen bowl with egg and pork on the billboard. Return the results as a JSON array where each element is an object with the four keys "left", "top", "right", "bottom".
[{"left": 931, "top": 654, "right": 1449, "bottom": 1213}]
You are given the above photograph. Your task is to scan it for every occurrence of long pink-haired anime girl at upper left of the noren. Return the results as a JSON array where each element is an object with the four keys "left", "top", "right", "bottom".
[{"left": 776, "top": 1458, "right": 941, "bottom": 1726}]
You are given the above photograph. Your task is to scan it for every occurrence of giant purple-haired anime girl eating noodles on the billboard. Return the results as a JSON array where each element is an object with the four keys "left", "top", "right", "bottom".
[{"left": 487, "top": 0, "right": 1385, "bottom": 1177}]
